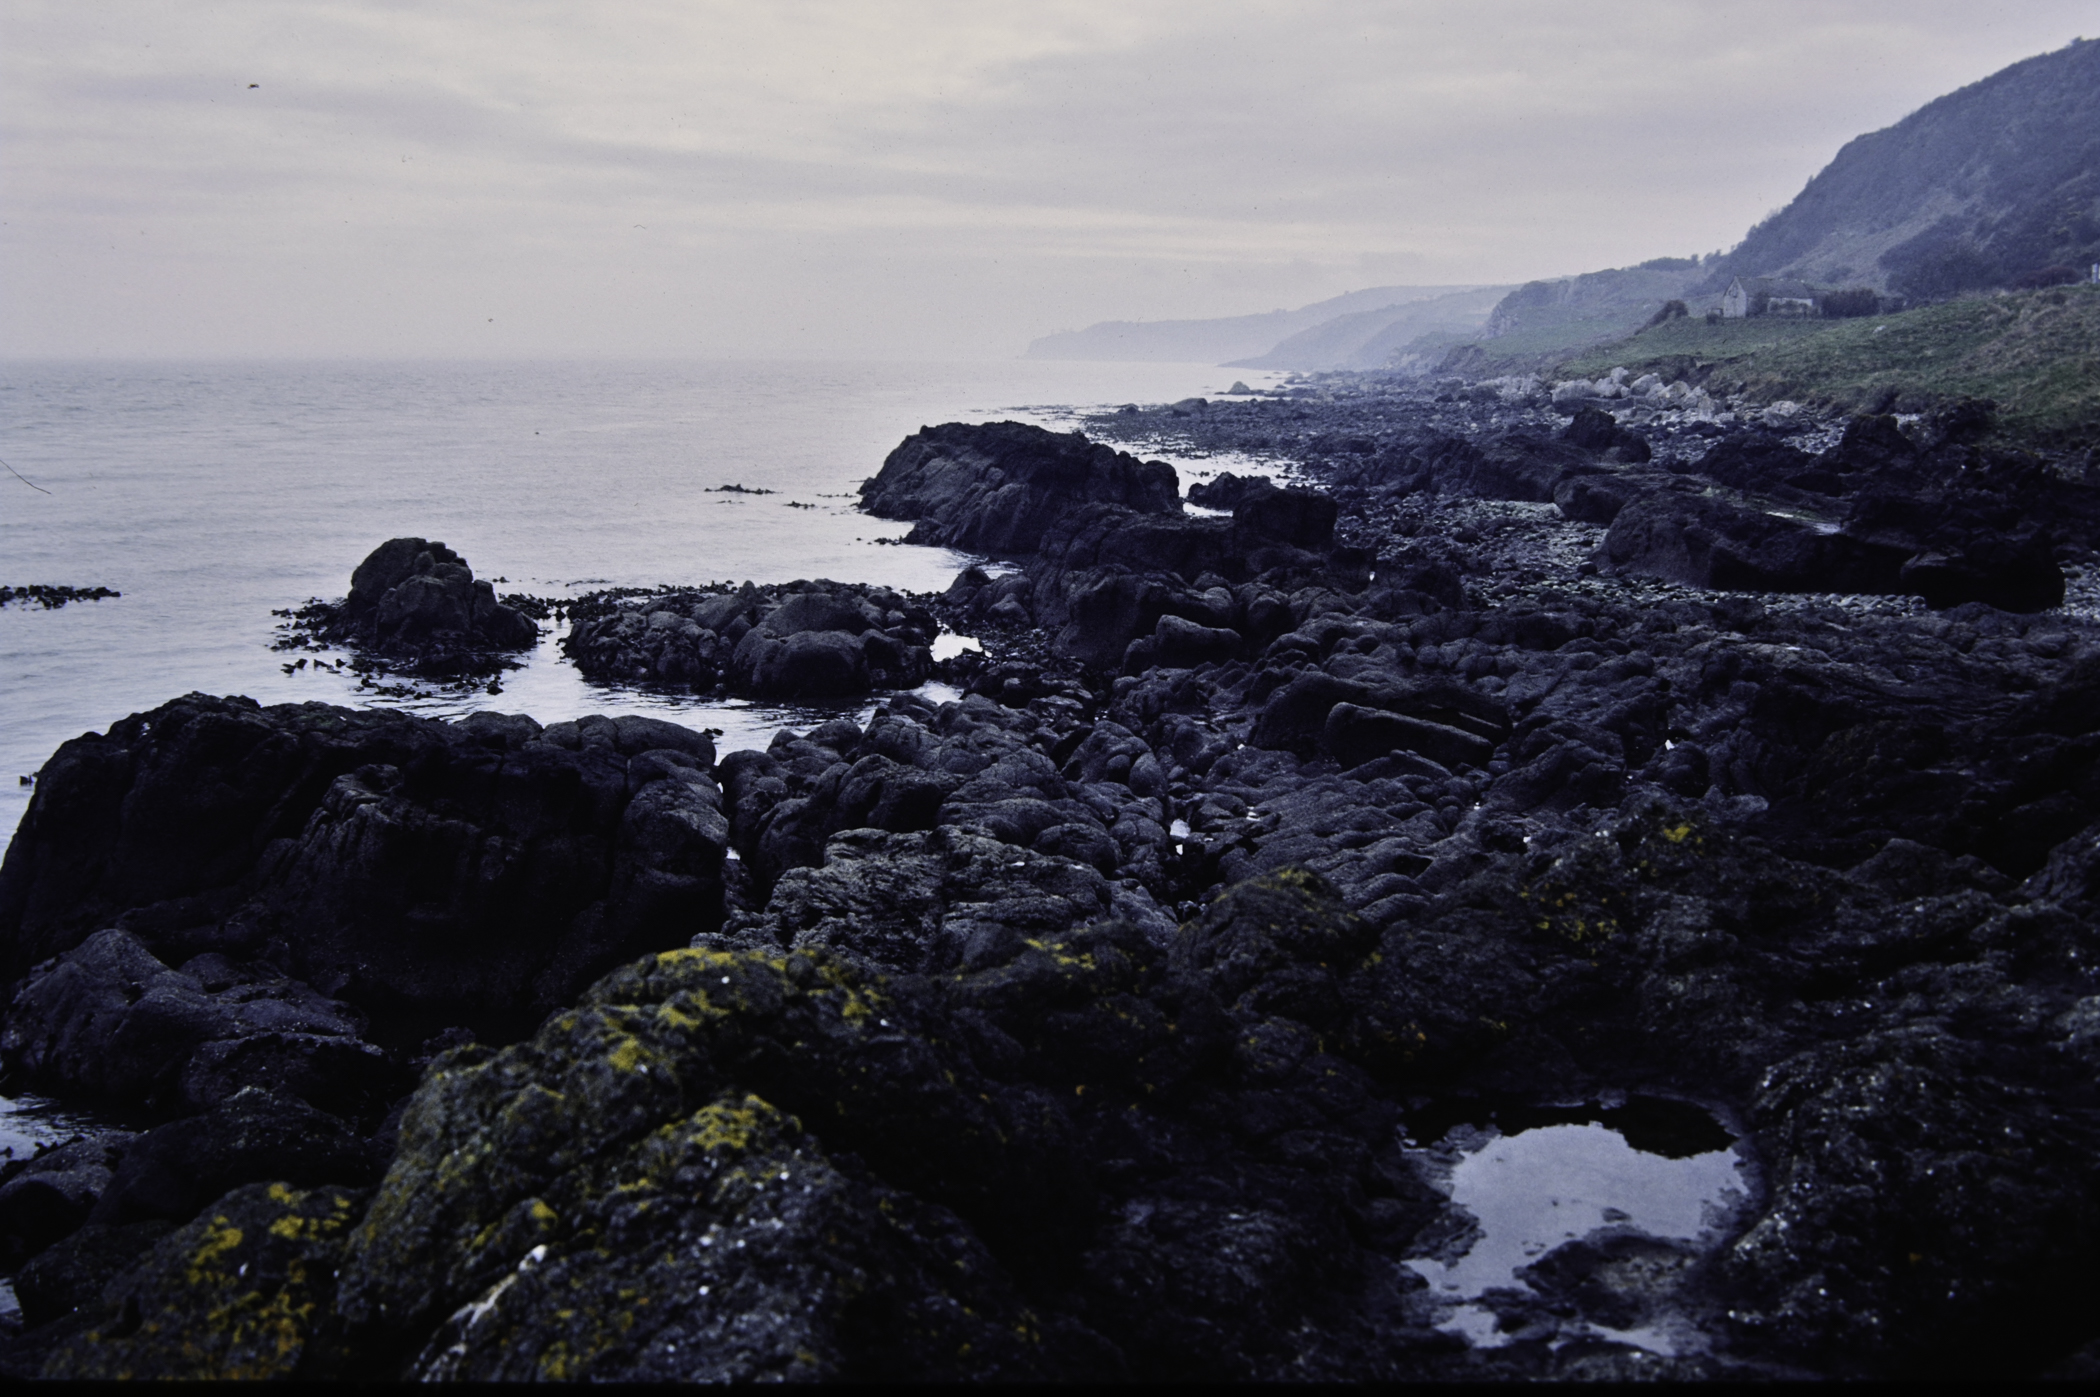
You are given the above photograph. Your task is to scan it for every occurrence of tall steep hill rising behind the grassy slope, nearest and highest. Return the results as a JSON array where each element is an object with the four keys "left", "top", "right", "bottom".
[{"left": 1707, "top": 40, "right": 2100, "bottom": 298}]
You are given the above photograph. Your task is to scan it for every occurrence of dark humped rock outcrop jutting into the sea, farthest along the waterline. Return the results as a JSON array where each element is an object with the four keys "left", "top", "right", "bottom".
[{"left": 861, "top": 422, "right": 1180, "bottom": 555}]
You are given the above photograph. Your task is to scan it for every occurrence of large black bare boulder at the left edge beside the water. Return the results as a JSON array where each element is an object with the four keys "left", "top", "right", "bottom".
[{"left": 0, "top": 695, "right": 729, "bottom": 1033}]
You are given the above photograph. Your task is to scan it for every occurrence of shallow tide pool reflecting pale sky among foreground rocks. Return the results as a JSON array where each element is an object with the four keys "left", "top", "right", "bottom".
[{"left": 1407, "top": 1122, "right": 1751, "bottom": 1355}]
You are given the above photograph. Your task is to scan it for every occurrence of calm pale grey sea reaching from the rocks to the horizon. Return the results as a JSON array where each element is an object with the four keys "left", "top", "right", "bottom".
[{"left": 0, "top": 361, "right": 1275, "bottom": 836}]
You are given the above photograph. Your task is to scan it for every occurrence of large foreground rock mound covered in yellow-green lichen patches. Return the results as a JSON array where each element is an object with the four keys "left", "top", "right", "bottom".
[{"left": 342, "top": 950, "right": 1113, "bottom": 1380}]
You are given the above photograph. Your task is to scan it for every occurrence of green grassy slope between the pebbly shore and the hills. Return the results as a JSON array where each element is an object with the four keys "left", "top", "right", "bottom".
[{"left": 1552, "top": 286, "right": 2100, "bottom": 447}]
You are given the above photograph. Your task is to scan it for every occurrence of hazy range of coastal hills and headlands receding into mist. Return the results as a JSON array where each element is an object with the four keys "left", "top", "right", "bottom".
[{"left": 1027, "top": 40, "right": 2100, "bottom": 376}]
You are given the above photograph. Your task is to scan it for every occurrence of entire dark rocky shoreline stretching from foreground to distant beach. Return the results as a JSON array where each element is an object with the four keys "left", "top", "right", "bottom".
[{"left": 0, "top": 376, "right": 2100, "bottom": 1380}]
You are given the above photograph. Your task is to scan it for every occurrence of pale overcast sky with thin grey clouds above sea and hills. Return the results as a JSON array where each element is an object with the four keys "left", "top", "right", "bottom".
[{"left": 0, "top": 0, "right": 2100, "bottom": 359}]
